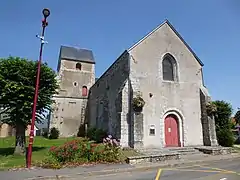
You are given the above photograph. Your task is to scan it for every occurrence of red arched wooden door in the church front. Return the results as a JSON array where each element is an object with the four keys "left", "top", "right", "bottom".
[{"left": 165, "top": 116, "right": 179, "bottom": 147}]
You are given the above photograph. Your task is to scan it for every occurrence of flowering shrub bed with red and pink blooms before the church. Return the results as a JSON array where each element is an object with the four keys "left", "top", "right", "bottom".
[{"left": 49, "top": 138, "right": 120, "bottom": 164}]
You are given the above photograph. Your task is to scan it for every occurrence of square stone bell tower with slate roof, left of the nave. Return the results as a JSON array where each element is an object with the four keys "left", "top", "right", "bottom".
[{"left": 50, "top": 46, "right": 95, "bottom": 137}]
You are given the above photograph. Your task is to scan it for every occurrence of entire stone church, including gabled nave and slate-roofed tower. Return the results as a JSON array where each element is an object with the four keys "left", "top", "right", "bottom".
[{"left": 50, "top": 20, "right": 217, "bottom": 148}]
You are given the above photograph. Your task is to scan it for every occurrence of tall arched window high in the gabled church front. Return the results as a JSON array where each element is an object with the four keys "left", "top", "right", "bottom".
[{"left": 162, "top": 54, "right": 177, "bottom": 81}]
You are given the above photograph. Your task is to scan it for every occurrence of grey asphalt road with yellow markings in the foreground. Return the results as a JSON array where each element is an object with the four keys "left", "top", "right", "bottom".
[{"left": 79, "top": 158, "right": 240, "bottom": 180}]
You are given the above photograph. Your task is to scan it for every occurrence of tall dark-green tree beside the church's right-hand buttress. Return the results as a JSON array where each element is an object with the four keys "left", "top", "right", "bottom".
[{"left": 213, "top": 101, "right": 234, "bottom": 146}]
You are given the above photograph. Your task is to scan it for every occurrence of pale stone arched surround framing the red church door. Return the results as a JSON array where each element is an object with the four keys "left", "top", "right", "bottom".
[{"left": 162, "top": 108, "right": 184, "bottom": 147}]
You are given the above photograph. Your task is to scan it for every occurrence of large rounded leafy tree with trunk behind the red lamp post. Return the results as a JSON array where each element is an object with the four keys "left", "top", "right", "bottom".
[{"left": 0, "top": 57, "right": 58, "bottom": 155}]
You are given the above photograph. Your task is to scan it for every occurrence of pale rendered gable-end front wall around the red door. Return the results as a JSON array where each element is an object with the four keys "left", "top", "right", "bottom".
[{"left": 128, "top": 23, "right": 203, "bottom": 147}]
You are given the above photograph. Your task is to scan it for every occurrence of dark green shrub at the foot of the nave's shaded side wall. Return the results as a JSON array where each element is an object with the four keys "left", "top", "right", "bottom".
[{"left": 87, "top": 128, "right": 107, "bottom": 143}]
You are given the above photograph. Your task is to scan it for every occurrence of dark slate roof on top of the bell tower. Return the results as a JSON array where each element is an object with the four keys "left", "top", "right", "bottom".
[{"left": 60, "top": 46, "right": 95, "bottom": 63}]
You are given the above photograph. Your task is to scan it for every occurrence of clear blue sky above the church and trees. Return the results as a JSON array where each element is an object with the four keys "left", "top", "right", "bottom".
[{"left": 0, "top": 0, "right": 240, "bottom": 111}]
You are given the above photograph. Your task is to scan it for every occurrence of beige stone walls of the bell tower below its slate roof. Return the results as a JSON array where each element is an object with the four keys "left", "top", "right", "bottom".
[{"left": 49, "top": 59, "right": 95, "bottom": 137}]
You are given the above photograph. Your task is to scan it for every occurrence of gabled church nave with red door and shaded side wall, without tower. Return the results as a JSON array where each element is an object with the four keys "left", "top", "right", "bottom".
[{"left": 49, "top": 21, "right": 217, "bottom": 148}]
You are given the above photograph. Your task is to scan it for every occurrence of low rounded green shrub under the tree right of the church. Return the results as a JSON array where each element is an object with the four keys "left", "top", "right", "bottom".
[{"left": 217, "top": 128, "right": 234, "bottom": 147}]
